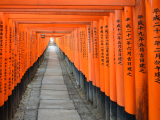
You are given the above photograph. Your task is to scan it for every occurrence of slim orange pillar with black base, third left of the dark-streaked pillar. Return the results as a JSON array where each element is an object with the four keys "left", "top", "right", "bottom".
[{"left": 109, "top": 13, "right": 117, "bottom": 120}]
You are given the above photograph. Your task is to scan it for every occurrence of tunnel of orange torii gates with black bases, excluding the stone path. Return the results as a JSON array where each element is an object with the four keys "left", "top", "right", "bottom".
[{"left": 0, "top": 0, "right": 160, "bottom": 120}]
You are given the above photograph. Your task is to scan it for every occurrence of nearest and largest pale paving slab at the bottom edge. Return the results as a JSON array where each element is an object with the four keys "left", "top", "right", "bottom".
[{"left": 38, "top": 109, "right": 81, "bottom": 120}]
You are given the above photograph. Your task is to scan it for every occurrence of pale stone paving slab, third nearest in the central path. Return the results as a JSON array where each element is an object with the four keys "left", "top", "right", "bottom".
[{"left": 40, "top": 90, "right": 69, "bottom": 100}]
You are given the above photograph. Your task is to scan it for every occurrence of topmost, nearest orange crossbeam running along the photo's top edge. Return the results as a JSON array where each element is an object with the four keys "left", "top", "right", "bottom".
[{"left": 0, "top": 0, "right": 135, "bottom": 6}]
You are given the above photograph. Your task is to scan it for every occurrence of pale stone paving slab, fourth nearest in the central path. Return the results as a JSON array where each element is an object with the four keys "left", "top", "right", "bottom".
[{"left": 41, "top": 84, "right": 67, "bottom": 91}]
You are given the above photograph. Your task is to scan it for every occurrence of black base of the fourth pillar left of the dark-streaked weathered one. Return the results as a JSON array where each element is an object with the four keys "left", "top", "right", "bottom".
[{"left": 105, "top": 95, "right": 110, "bottom": 120}]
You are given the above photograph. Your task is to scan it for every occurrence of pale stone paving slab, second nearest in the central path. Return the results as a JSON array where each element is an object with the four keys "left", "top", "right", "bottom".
[{"left": 39, "top": 100, "right": 75, "bottom": 110}]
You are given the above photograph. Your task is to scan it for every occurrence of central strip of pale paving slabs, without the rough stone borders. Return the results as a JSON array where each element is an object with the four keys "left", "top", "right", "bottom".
[{"left": 38, "top": 42, "right": 81, "bottom": 120}]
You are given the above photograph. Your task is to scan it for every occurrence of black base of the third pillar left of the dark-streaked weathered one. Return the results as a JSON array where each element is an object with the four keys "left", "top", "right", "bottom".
[{"left": 110, "top": 100, "right": 117, "bottom": 120}]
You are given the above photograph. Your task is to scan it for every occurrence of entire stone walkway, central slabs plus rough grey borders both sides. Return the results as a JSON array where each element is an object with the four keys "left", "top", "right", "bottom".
[{"left": 12, "top": 42, "right": 97, "bottom": 120}]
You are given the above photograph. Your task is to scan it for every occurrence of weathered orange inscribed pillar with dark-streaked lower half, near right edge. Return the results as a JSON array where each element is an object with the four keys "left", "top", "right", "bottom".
[{"left": 134, "top": 0, "right": 148, "bottom": 120}]
